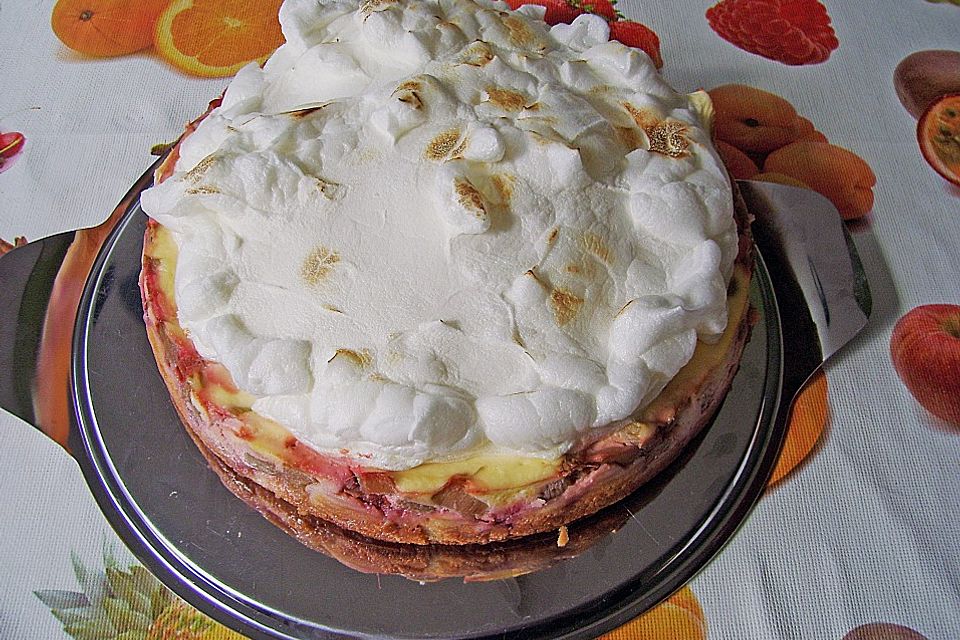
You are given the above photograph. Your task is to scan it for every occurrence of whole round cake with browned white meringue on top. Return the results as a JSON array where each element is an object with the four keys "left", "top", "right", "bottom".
[{"left": 141, "top": 0, "right": 752, "bottom": 544}]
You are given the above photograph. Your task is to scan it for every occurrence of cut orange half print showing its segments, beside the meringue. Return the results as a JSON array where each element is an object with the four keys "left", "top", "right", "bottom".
[{"left": 154, "top": 0, "right": 283, "bottom": 78}]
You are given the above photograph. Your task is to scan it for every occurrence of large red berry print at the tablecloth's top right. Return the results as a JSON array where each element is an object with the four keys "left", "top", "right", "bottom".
[{"left": 707, "top": 0, "right": 840, "bottom": 65}]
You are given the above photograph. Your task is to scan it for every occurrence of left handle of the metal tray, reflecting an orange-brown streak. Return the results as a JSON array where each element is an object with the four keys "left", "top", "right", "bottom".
[{"left": 0, "top": 158, "right": 163, "bottom": 453}]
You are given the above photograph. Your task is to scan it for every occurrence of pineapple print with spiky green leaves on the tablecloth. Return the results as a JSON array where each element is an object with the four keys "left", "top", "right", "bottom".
[{"left": 34, "top": 551, "right": 245, "bottom": 640}]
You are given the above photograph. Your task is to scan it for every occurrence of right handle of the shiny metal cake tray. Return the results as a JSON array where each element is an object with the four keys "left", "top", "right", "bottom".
[{"left": 738, "top": 180, "right": 873, "bottom": 407}]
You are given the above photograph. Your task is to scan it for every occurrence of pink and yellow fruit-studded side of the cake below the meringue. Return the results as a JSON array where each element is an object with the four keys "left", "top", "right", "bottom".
[{"left": 141, "top": 191, "right": 754, "bottom": 544}]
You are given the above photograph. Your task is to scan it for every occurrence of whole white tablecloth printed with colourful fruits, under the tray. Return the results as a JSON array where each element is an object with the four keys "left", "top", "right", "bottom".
[{"left": 0, "top": 0, "right": 960, "bottom": 640}]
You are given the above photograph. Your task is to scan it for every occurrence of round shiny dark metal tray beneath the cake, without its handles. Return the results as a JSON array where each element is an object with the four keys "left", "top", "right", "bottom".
[{"left": 71, "top": 196, "right": 792, "bottom": 638}]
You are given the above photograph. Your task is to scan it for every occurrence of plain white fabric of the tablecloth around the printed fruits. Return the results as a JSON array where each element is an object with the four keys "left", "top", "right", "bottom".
[{"left": 0, "top": 0, "right": 960, "bottom": 640}]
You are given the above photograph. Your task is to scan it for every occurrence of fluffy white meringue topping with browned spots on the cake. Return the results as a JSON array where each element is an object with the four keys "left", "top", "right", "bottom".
[{"left": 141, "top": 0, "right": 738, "bottom": 470}]
